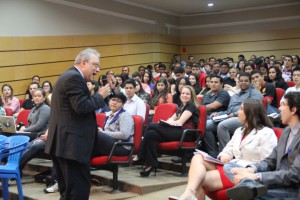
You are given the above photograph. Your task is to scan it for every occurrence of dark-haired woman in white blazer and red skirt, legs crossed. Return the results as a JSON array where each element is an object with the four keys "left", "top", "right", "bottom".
[{"left": 172, "top": 99, "right": 277, "bottom": 200}]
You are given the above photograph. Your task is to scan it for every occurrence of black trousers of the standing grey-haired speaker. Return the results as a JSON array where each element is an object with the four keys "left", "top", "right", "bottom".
[{"left": 52, "top": 156, "right": 91, "bottom": 200}]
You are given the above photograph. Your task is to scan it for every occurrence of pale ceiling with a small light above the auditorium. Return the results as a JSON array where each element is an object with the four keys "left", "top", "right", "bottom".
[{"left": 115, "top": 0, "right": 299, "bottom": 16}]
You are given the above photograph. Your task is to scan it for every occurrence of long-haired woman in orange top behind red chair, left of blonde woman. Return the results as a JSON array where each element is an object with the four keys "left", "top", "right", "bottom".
[{"left": 149, "top": 78, "right": 173, "bottom": 115}]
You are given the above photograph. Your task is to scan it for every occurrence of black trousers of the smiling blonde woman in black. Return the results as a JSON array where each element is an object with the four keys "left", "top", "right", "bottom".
[{"left": 138, "top": 123, "right": 188, "bottom": 167}]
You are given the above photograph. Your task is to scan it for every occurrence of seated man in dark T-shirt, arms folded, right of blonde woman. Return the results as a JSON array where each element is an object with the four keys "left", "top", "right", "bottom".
[{"left": 202, "top": 74, "right": 230, "bottom": 116}]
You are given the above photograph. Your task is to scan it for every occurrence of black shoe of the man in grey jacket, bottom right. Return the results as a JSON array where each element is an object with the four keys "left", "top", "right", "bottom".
[{"left": 226, "top": 180, "right": 268, "bottom": 200}]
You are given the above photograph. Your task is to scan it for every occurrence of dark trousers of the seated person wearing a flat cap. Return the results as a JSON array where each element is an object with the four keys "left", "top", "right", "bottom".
[{"left": 93, "top": 132, "right": 130, "bottom": 157}]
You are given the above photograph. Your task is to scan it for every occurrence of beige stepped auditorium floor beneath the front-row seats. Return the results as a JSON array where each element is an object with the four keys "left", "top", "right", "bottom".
[{"left": 5, "top": 156, "right": 209, "bottom": 200}]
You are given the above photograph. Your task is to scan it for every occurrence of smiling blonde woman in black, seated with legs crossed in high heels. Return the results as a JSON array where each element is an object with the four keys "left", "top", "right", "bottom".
[{"left": 133, "top": 85, "right": 199, "bottom": 177}]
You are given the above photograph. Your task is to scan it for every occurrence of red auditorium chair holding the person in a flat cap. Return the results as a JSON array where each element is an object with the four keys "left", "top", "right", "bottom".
[{"left": 90, "top": 113, "right": 143, "bottom": 192}]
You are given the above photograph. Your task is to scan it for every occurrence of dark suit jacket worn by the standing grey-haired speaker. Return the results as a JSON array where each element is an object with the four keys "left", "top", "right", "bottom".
[{"left": 45, "top": 67, "right": 105, "bottom": 164}]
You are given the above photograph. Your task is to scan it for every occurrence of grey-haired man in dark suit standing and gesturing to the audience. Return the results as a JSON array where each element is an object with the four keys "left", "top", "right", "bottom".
[{"left": 45, "top": 49, "right": 110, "bottom": 200}]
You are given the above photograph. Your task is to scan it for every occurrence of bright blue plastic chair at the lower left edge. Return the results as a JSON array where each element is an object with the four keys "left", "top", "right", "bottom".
[{"left": 0, "top": 136, "right": 29, "bottom": 200}]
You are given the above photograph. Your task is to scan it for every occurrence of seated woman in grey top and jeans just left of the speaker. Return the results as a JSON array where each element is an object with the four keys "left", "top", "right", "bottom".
[{"left": 20, "top": 88, "right": 50, "bottom": 170}]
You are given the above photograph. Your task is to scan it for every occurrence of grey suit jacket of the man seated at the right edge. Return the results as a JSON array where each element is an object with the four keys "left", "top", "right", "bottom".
[{"left": 255, "top": 127, "right": 300, "bottom": 191}]
